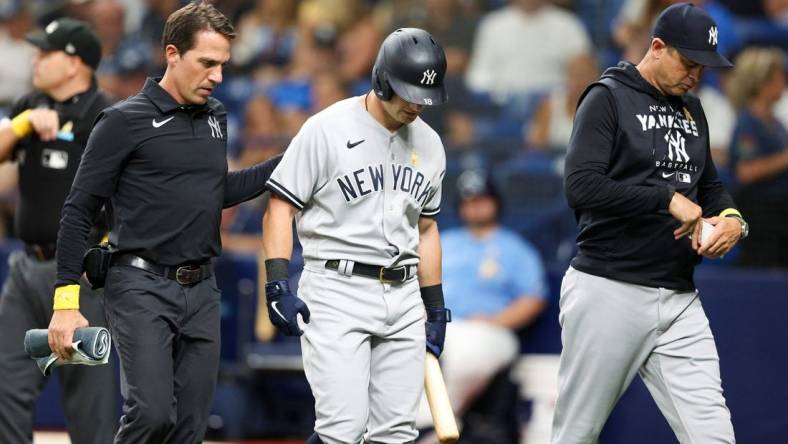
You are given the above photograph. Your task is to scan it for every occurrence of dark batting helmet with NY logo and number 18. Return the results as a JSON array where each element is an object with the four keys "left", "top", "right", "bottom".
[{"left": 372, "top": 28, "right": 448, "bottom": 105}]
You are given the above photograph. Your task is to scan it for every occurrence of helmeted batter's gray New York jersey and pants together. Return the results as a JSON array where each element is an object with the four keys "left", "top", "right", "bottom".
[{"left": 268, "top": 97, "right": 446, "bottom": 444}]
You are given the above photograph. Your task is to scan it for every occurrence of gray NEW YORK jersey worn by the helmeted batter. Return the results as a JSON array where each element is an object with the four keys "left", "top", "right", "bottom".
[{"left": 268, "top": 97, "right": 446, "bottom": 267}]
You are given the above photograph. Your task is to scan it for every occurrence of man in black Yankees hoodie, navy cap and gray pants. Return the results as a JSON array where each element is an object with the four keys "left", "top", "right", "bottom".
[{"left": 552, "top": 3, "right": 748, "bottom": 444}]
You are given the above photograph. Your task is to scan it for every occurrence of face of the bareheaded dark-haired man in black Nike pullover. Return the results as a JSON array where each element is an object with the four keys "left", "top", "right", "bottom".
[{"left": 167, "top": 30, "right": 230, "bottom": 105}]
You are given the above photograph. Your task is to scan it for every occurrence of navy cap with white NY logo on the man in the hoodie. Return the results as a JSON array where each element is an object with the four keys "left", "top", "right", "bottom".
[{"left": 654, "top": 3, "right": 733, "bottom": 68}]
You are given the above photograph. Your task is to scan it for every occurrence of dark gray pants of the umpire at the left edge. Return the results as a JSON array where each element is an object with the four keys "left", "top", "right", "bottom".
[{"left": 0, "top": 251, "right": 118, "bottom": 444}]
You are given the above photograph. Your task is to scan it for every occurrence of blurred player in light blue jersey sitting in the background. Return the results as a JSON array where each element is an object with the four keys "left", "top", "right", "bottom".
[{"left": 417, "top": 170, "right": 547, "bottom": 427}]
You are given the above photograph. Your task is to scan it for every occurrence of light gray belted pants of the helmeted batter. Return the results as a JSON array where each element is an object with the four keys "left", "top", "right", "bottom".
[{"left": 298, "top": 264, "right": 425, "bottom": 444}]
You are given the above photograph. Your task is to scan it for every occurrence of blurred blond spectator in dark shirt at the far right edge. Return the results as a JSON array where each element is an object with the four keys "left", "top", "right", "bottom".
[{"left": 728, "top": 48, "right": 788, "bottom": 268}]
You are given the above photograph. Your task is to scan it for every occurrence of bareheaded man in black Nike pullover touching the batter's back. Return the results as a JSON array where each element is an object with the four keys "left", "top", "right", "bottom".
[{"left": 49, "top": 2, "right": 278, "bottom": 444}]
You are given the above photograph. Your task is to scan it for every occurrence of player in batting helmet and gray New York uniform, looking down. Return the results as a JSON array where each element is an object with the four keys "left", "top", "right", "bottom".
[{"left": 263, "top": 28, "right": 450, "bottom": 444}]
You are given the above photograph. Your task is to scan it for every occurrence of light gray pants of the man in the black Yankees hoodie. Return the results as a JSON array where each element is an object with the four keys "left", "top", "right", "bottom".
[{"left": 552, "top": 267, "right": 735, "bottom": 444}]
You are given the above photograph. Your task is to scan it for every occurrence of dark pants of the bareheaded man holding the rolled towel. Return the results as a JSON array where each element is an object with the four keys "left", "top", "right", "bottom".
[{"left": 104, "top": 265, "right": 220, "bottom": 444}]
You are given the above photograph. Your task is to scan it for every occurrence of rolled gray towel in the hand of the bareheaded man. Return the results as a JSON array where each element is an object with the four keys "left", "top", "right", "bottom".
[{"left": 25, "top": 327, "right": 112, "bottom": 375}]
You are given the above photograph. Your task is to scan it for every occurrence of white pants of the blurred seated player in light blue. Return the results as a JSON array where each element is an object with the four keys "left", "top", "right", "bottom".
[{"left": 416, "top": 320, "right": 520, "bottom": 428}]
